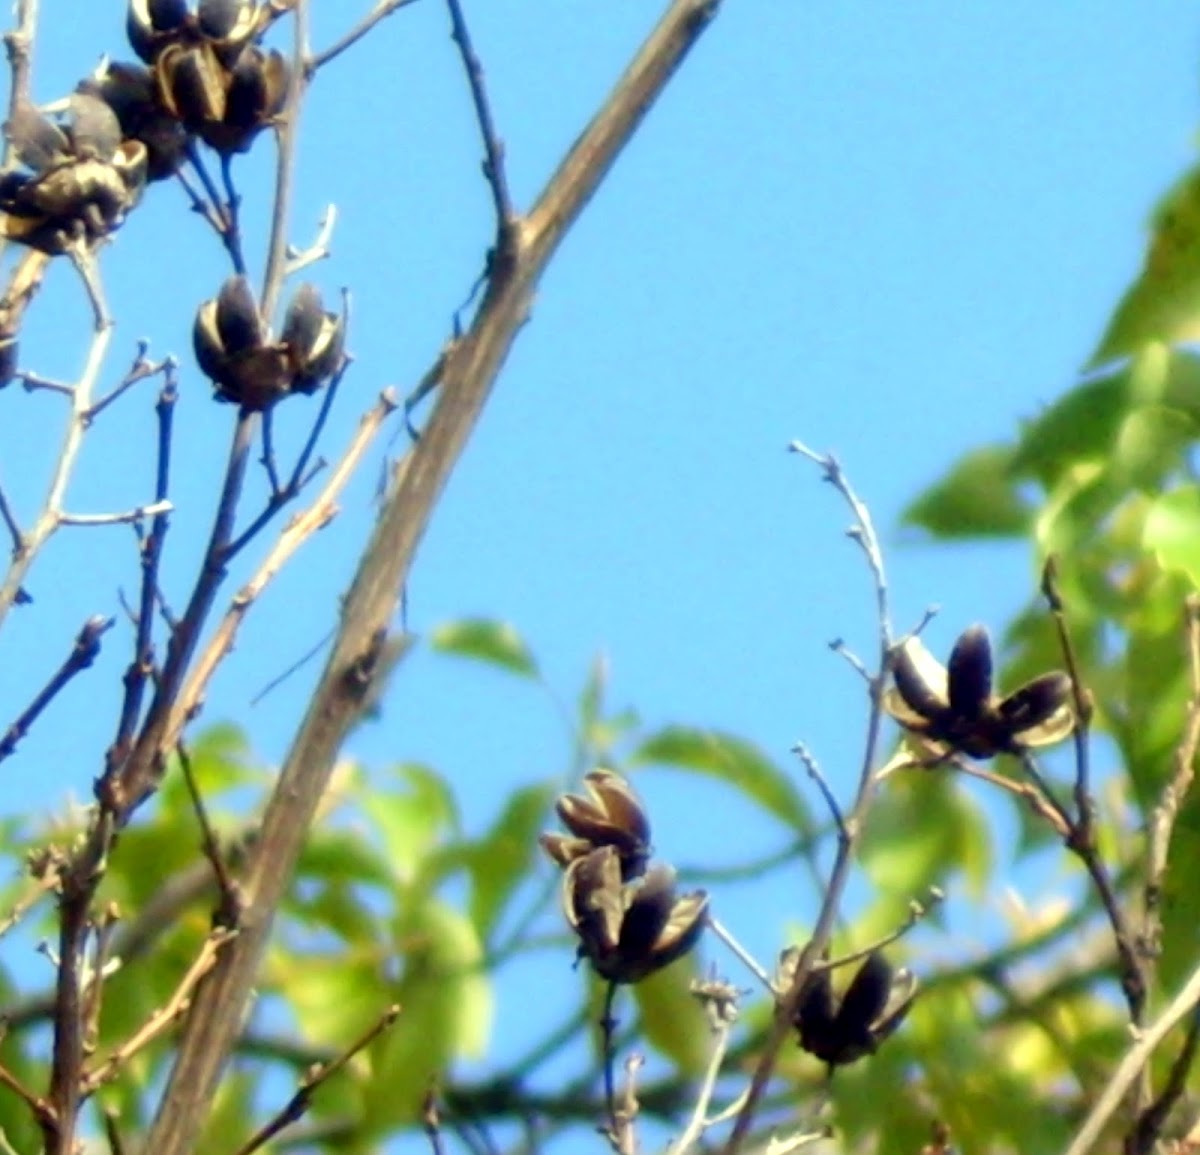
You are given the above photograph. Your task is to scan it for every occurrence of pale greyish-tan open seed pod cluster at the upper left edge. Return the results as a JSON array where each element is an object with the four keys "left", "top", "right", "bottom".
[{"left": 0, "top": 102, "right": 146, "bottom": 253}]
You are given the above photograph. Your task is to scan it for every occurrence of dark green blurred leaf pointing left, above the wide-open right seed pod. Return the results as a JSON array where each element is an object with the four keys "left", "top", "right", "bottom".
[{"left": 904, "top": 445, "right": 1032, "bottom": 538}]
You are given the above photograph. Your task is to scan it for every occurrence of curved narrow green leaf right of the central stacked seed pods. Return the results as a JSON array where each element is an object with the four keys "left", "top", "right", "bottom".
[{"left": 629, "top": 726, "right": 812, "bottom": 834}]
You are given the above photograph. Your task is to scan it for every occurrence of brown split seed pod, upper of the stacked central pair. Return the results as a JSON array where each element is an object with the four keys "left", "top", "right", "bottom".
[{"left": 540, "top": 768, "right": 650, "bottom": 881}]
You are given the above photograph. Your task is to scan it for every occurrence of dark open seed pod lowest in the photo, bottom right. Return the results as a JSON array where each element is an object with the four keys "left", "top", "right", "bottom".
[{"left": 794, "top": 951, "right": 917, "bottom": 1069}]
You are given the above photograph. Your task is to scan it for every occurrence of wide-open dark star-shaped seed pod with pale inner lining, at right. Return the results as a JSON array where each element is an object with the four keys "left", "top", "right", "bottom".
[{"left": 883, "top": 626, "right": 1075, "bottom": 759}]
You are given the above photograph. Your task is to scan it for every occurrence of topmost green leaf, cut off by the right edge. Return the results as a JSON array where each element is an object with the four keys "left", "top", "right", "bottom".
[{"left": 1091, "top": 169, "right": 1200, "bottom": 365}]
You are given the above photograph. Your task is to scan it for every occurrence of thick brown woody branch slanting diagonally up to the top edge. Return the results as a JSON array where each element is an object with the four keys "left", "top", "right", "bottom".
[{"left": 146, "top": 0, "right": 719, "bottom": 1155}]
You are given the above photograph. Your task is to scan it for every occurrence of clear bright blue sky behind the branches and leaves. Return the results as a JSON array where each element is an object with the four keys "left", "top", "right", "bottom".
[{"left": 0, "top": 0, "right": 1198, "bottom": 1142}]
